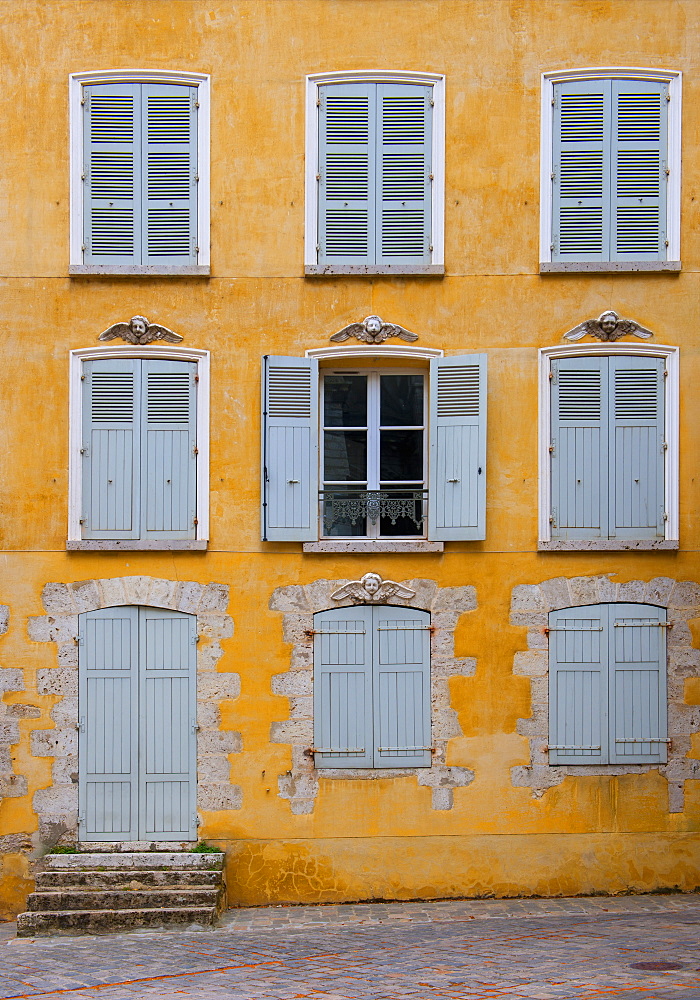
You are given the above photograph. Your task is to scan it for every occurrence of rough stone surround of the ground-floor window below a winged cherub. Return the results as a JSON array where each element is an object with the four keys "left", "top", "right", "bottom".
[{"left": 270, "top": 578, "right": 477, "bottom": 816}]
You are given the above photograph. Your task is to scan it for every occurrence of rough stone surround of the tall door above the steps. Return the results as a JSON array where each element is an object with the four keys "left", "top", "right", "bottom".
[{"left": 22, "top": 576, "right": 242, "bottom": 852}]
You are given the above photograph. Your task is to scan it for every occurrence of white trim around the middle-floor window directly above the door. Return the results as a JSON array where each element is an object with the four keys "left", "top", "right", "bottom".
[{"left": 68, "top": 346, "right": 210, "bottom": 549}]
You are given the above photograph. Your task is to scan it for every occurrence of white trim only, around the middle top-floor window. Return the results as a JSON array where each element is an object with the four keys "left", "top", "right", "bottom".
[{"left": 304, "top": 69, "right": 445, "bottom": 274}]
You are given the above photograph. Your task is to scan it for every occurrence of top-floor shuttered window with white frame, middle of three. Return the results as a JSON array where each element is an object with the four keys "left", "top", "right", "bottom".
[{"left": 306, "top": 73, "right": 444, "bottom": 274}]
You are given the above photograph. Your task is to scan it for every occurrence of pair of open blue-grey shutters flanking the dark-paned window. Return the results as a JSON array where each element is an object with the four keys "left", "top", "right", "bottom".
[{"left": 262, "top": 354, "right": 486, "bottom": 542}]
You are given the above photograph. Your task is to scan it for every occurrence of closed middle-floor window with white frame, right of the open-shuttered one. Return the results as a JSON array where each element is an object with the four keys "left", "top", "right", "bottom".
[{"left": 540, "top": 344, "right": 678, "bottom": 548}]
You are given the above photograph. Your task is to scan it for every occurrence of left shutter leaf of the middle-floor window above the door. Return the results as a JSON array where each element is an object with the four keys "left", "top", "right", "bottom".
[{"left": 81, "top": 358, "right": 141, "bottom": 539}]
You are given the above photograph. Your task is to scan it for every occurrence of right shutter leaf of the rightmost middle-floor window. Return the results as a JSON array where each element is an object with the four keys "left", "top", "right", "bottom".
[{"left": 606, "top": 355, "right": 665, "bottom": 538}]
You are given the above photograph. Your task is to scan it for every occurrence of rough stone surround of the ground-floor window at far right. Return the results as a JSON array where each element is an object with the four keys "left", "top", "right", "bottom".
[{"left": 510, "top": 574, "right": 700, "bottom": 813}]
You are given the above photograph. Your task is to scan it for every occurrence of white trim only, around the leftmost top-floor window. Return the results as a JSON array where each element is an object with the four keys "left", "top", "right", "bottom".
[{"left": 68, "top": 69, "right": 210, "bottom": 274}]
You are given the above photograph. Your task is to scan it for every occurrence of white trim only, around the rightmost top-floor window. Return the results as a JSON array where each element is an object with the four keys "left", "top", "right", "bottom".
[{"left": 540, "top": 66, "right": 682, "bottom": 271}]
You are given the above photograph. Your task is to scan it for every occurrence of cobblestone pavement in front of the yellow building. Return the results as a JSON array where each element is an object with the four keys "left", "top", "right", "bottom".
[{"left": 0, "top": 895, "right": 700, "bottom": 1000}]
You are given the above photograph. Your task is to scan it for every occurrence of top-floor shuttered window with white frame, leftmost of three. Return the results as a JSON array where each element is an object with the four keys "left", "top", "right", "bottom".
[{"left": 70, "top": 71, "right": 209, "bottom": 274}]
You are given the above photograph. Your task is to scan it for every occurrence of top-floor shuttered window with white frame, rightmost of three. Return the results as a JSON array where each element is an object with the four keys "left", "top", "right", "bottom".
[{"left": 540, "top": 69, "right": 680, "bottom": 271}]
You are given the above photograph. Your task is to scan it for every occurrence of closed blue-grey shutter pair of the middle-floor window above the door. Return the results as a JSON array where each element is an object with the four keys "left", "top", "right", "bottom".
[{"left": 81, "top": 358, "right": 197, "bottom": 540}]
